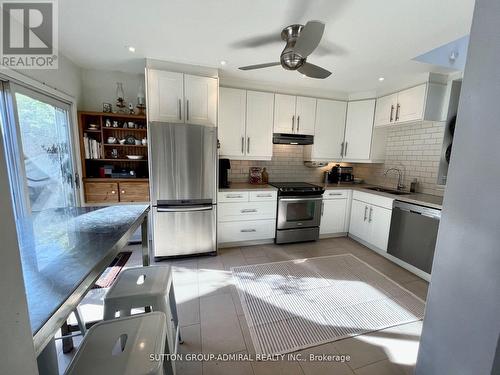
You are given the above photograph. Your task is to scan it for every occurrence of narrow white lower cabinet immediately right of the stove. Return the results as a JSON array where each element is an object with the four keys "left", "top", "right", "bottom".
[{"left": 319, "top": 190, "right": 350, "bottom": 236}]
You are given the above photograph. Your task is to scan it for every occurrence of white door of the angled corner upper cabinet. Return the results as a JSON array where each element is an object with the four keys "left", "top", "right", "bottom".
[{"left": 344, "top": 99, "right": 375, "bottom": 160}]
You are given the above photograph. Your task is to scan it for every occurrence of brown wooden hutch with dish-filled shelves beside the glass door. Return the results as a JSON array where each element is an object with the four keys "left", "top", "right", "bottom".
[{"left": 78, "top": 111, "right": 149, "bottom": 203}]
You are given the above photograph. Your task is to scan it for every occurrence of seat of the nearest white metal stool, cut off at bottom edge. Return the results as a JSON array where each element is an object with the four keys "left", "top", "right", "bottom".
[{"left": 65, "top": 311, "right": 167, "bottom": 375}]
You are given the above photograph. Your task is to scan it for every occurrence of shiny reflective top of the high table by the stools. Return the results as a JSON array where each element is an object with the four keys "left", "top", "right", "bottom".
[{"left": 18, "top": 205, "right": 149, "bottom": 334}]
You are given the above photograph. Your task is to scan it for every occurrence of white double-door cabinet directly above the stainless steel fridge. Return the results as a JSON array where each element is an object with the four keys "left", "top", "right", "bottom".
[{"left": 147, "top": 69, "right": 217, "bottom": 126}]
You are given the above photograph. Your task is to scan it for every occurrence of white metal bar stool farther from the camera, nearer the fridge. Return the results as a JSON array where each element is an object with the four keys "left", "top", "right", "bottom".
[{"left": 104, "top": 266, "right": 182, "bottom": 353}]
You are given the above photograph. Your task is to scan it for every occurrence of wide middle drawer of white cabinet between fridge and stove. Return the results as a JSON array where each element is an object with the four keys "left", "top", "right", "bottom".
[{"left": 218, "top": 200, "right": 277, "bottom": 222}]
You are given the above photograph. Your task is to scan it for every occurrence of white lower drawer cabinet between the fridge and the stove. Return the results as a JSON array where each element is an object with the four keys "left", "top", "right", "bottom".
[{"left": 217, "top": 190, "right": 278, "bottom": 246}]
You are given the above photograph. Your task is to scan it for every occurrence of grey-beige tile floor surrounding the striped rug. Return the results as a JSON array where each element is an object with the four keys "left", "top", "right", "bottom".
[{"left": 59, "top": 238, "right": 428, "bottom": 375}]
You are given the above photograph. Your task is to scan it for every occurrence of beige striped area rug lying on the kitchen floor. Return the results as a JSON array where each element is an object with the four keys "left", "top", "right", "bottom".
[{"left": 231, "top": 254, "right": 425, "bottom": 354}]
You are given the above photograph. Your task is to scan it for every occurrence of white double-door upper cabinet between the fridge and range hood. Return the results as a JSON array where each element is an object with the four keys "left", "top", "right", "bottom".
[{"left": 219, "top": 87, "right": 274, "bottom": 160}]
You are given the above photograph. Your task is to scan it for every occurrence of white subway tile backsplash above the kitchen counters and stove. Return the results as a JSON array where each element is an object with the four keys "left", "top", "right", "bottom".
[{"left": 229, "top": 121, "right": 445, "bottom": 196}]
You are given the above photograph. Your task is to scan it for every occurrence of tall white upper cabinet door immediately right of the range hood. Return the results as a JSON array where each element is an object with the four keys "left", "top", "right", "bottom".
[{"left": 311, "top": 99, "right": 347, "bottom": 161}]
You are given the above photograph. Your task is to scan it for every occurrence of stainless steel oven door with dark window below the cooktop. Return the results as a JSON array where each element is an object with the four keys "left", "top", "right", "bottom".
[{"left": 277, "top": 196, "right": 323, "bottom": 229}]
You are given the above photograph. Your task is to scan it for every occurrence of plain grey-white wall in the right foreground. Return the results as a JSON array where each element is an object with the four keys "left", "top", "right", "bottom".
[{"left": 415, "top": 0, "right": 500, "bottom": 375}]
